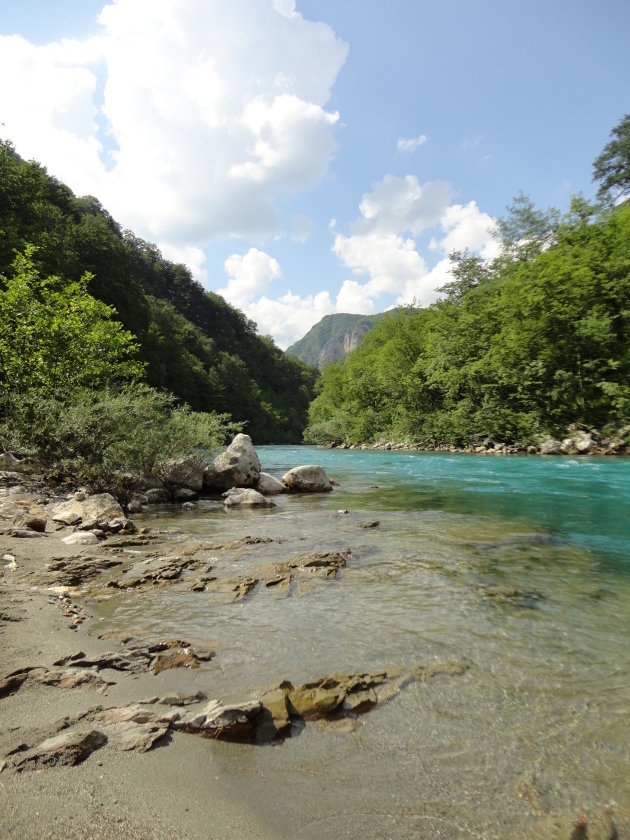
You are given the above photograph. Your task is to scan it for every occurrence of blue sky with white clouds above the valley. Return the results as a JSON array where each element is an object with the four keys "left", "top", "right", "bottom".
[{"left": 0, "top": 0, "right": 630, "bottom": 348}]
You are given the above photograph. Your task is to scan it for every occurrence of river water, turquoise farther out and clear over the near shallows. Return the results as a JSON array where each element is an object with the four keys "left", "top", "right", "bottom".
[{"left": 87, "top": 447, "right": 630, "bottom": 838}]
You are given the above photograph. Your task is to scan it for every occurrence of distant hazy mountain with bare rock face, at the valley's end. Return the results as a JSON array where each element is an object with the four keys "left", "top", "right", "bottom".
[{"left": 285, "top": 313, "right": 383, "bottom": 370}]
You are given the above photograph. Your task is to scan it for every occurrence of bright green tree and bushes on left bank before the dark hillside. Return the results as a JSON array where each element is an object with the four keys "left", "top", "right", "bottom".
[{"left": 0, "top": 253, "right": 240, "bottom": 503}]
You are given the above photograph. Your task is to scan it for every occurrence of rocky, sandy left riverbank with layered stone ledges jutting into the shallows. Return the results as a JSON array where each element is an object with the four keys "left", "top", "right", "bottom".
[{"left": 0, "top": 436, "right": 619, "bottom": 840}]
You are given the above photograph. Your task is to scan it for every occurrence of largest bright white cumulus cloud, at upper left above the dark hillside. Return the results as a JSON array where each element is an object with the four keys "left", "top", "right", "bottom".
[{"left": 0, "top": 0, "right": 348, "bottom": 250}]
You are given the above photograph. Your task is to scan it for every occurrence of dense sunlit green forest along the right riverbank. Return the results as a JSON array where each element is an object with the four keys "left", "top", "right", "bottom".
[{"left": 305, "top": 115, "right": 630, "bottom": 452}]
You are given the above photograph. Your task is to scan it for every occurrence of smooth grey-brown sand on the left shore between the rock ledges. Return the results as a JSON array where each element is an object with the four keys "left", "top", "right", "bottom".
[{"left": 0, "top": 506, "right": 282, "bottom": 840}]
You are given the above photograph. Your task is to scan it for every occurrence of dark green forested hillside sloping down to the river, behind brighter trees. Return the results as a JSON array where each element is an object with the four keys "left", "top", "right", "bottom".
[{"left": 0, "top": 143, "right": 317, "bottom": 443}]
